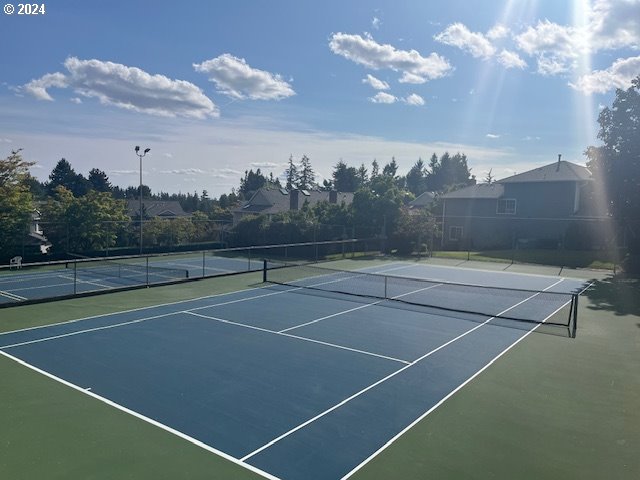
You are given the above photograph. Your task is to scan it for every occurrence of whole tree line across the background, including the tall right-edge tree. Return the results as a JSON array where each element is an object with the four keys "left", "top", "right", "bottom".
[{"left": 0, "top": 76, "right": 640, "bottom": 270}]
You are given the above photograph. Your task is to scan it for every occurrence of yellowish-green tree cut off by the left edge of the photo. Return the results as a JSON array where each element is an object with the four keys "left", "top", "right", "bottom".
[{"left": 0, "top": 150, "right": 34, "bottom": 256}]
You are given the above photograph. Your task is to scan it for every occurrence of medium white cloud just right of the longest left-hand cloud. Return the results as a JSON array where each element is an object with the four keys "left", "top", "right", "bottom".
[{"left": 193, "top": 53, "right": 296, "bottom": 100}]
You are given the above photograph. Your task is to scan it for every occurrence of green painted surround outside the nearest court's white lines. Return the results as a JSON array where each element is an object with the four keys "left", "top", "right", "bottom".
[{"left": 0, "top": 261, "right": 640, "bottom": 480}]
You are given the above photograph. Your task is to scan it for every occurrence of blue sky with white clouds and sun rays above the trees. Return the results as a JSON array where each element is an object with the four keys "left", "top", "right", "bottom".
[{"left": 0, "top": 0, "right": 640, "bottom": 197}]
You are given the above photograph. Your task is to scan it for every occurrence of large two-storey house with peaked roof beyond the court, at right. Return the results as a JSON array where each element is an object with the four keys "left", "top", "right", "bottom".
[{"left": 441, "top": 156, "right": 610, "bottom": 249}]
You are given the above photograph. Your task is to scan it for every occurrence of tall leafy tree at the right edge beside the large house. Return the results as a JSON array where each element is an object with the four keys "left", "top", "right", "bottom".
[{"left": 585, "top": 75, "right": 640, "bottom": 262}]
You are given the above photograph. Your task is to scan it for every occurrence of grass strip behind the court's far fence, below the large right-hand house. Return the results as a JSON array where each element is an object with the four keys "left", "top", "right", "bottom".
[{"left": 433, "top": 249, "right": 616, "bottom": 270}]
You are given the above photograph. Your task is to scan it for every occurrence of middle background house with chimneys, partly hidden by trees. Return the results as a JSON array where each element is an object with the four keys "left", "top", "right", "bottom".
[{"left": 232, "top": 188, "right": 353, "bottom": 225}]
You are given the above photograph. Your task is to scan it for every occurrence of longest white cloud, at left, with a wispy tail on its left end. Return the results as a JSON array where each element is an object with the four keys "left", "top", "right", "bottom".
[{"left": 21, "top": 57, "right": 219, "bottom": 118}]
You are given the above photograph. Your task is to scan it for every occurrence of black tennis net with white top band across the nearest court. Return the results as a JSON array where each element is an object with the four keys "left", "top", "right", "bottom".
[{"left": 263, "top": 264, "right": 578, "bottom": 336}]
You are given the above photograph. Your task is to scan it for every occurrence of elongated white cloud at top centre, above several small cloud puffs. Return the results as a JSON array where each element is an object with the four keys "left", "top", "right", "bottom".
[{"left": 329, "top": 33, "right": 453, "bottom": 83}]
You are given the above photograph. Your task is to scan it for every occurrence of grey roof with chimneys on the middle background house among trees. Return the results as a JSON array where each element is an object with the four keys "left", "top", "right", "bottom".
[{"left": 235, "top": 188, "right": 353, "bottom": 214}]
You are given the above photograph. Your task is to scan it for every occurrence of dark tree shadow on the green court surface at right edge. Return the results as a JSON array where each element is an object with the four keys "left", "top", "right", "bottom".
[{"left": 584, "top": 277, "right": 640, "bottom": 316}]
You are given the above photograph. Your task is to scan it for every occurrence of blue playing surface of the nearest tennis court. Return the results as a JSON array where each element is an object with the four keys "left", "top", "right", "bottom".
[{"left": 0, "top": 264, "right": 584, "bottom": 479}]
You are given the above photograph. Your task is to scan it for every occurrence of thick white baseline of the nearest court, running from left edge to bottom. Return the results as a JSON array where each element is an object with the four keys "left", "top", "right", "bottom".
[{"left": 0, "top": 350, "right": 280, "bottom": 480}]
